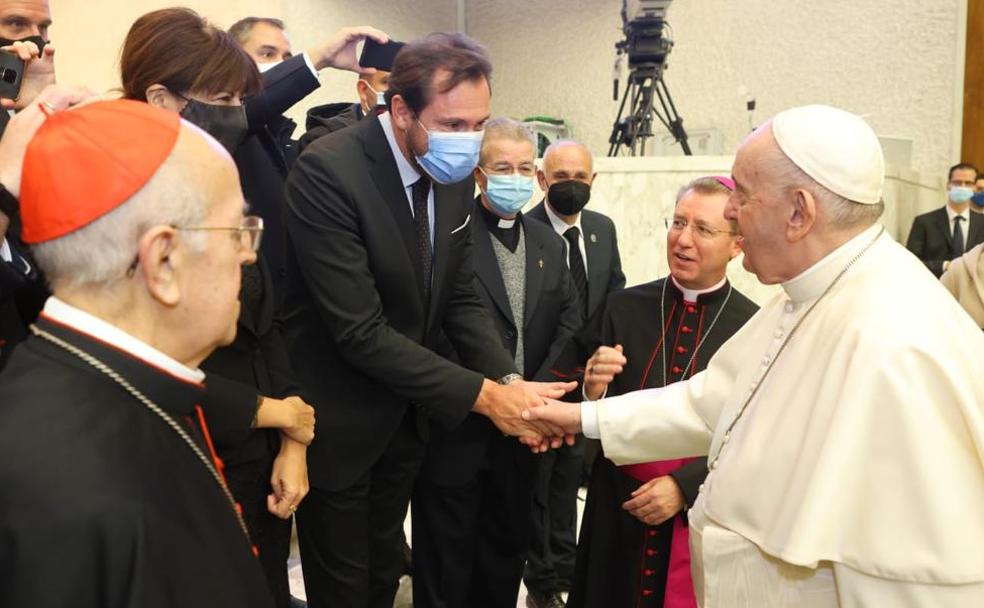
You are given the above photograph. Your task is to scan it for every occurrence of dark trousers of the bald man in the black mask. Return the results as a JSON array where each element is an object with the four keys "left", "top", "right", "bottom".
[{"left": 523, "top": 437, "right": 584, "bottom": 593}]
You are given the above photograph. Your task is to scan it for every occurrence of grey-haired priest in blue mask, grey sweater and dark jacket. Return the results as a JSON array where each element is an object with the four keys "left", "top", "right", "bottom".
[{"left": 412, "top": 118, "right": 582, "bottom": 608}]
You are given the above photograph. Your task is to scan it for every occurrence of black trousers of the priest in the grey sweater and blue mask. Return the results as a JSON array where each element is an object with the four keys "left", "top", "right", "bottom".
[{"left": 412, "top": 430, "right": 537, "bottom": 608}]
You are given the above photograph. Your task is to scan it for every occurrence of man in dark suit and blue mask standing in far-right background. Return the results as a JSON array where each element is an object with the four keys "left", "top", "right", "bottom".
[{"left": 905, "top": 163, "right": 984, "bottom": 277}]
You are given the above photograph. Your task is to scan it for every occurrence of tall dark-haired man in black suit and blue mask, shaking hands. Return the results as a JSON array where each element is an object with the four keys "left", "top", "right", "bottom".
[{"left": 285, "top": 34, "right": 573, "bottom": 608}]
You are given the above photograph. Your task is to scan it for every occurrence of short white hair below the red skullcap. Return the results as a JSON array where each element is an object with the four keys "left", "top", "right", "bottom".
[{"left": 31, "top": 152, "right": 208, "bottom": 288}]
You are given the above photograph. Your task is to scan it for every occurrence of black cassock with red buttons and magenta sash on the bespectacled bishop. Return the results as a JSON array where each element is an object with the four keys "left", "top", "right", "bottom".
[{"left": 568, "top": 278, "right": 758, "bottom": 608}]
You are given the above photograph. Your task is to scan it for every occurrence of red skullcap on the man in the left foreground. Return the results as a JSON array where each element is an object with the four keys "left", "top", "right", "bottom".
[{"left": 20, "top": 99, "right": 181, "bottom": 243}]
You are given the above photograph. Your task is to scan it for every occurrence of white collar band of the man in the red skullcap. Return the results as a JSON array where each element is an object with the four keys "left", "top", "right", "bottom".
[{"left": 42, "top": 296, "right": 205, "bottom": 383}]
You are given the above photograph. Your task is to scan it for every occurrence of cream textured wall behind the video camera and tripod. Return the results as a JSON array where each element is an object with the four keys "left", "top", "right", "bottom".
[{"left": 467, "top": 0, "right": 966, "bottom": 175}]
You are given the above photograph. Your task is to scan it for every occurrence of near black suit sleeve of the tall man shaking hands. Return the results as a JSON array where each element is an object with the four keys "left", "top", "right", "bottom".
[{"left": 286, "top": 150, "right": 498, "bottom": 420}]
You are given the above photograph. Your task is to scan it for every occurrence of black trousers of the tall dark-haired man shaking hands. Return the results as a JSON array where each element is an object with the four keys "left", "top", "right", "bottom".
[{"left": 297, "top": 409, "right": 424, "bottom": 608}]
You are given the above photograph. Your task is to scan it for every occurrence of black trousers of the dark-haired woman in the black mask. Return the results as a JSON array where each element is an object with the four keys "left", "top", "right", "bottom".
[{"left": 225, "top": 459, "right": 291, "bottom": 608}]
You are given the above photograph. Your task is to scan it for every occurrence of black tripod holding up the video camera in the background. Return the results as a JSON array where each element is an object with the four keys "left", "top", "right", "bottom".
[{"left": 608, "top": 64, "right": 692, "bottom": 156}]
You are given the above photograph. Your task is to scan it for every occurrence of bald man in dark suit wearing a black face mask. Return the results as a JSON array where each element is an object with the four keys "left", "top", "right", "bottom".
[{"left": 523, "top": 140, "right": 625, "bottom": 608}]
